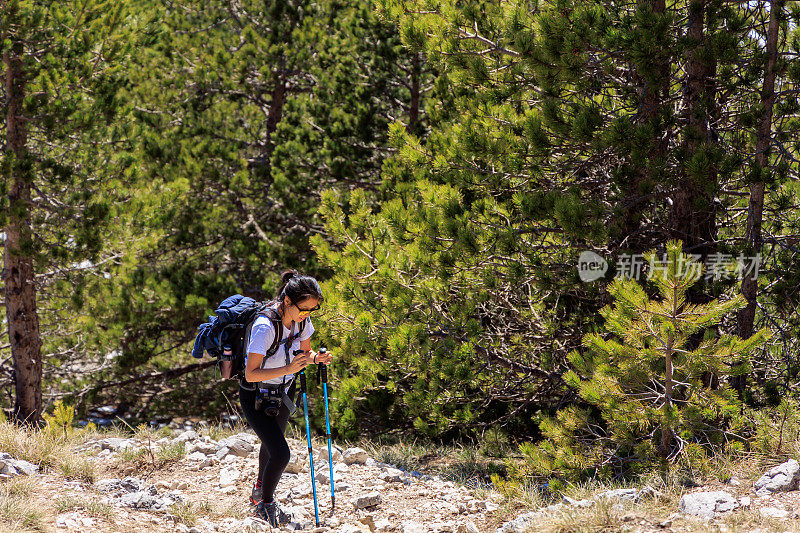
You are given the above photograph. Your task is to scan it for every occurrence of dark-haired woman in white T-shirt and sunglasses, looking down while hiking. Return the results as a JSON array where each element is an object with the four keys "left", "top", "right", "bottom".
[{"left": 239, "top": 270, "right": 331, "bottom": 526}]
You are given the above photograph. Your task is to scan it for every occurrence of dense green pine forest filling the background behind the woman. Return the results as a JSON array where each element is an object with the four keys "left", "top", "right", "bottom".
[{"left": 0, "top": 0, "right": 800, "bottom": 482}]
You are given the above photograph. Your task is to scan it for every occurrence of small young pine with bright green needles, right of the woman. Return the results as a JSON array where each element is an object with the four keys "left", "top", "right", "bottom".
[{"left": 515, "top": 241, "right": 770, "bottom": 479}]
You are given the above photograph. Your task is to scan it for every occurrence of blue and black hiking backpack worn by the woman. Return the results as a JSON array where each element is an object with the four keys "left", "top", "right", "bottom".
[{"left": 192, "top": 294, "right": 306, "bottom": 381}]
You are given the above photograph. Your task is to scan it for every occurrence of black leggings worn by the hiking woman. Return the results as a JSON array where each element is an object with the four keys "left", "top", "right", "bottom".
[{"left": 239, "top": 383, "right": 295, "bottom": 503}]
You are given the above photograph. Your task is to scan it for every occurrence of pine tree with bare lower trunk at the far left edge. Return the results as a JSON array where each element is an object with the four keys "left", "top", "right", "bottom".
[{"left": 0, "top": 1, "right": 127, "bottom": 424}]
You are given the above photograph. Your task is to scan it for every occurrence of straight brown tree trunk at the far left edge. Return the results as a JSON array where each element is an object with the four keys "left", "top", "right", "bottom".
[{"left": 3, "top": 43, "right": 42, "bottom": 425}]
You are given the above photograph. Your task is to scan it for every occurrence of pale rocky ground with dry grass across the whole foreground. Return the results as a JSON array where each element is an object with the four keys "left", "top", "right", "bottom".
[{"left": 0, "top": 424, "right": 800, "bottom": 533}]
